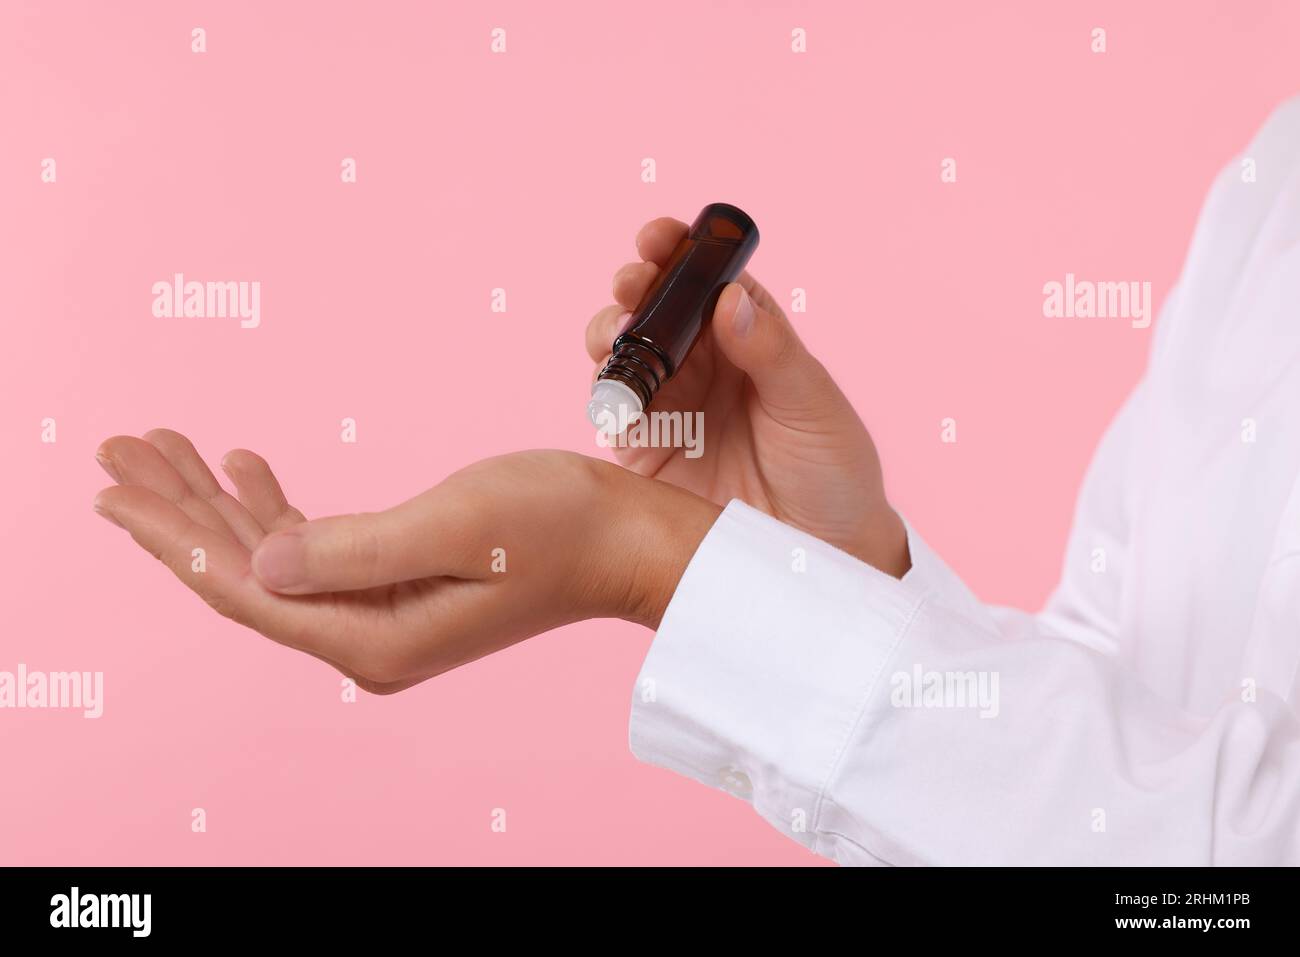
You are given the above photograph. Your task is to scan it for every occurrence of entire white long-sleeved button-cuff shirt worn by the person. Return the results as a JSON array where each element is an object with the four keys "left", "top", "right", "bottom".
[{"left": 631, "top": 100, "right": 1300, "bottom": 865}]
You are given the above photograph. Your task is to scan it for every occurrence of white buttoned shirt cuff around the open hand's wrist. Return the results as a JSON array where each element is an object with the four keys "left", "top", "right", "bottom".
[{"left": 629, "top": 501, "right": 943, "bottom": 850}]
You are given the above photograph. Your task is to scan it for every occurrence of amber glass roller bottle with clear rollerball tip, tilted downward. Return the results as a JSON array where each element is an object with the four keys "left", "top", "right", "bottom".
[{"left": 586, "top": 203, "right": 758, "bottom": 436}]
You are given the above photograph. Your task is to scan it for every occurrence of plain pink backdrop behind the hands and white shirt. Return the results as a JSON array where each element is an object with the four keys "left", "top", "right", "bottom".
[{"left": 0, "top": 0, "right": 1300, "bottom": 865}]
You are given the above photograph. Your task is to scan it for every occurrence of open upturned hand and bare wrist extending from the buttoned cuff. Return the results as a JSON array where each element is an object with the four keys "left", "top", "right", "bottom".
[{"left": 95, "top": 429, "right": 719, "bottom": 693}]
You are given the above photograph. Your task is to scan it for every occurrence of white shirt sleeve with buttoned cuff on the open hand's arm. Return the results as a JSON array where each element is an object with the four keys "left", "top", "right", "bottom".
[{"left": 631, "top": 501, "right": 1300, "bottom": 865}]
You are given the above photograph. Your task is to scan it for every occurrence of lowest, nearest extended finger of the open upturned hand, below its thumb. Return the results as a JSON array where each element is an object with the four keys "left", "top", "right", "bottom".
[{"left": 95, "top": 485, "right": 356, "bottom": 662}]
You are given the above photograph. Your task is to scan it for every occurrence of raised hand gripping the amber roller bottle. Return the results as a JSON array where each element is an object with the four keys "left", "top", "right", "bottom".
[{"left": 586, "top": 218, "right": 910, "bottom": 576}]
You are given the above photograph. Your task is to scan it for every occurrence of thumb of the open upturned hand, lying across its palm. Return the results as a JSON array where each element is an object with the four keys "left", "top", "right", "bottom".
[{"left": 252, "top": 506, "right": 449, "bottom": 594}]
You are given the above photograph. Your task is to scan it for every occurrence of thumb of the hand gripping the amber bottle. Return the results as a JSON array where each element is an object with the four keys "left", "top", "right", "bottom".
[{"left": 712, "top": 282, "right": 857, "bottom": 424}]
